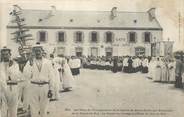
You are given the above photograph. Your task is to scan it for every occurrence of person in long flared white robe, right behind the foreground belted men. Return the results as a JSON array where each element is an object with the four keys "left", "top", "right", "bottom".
[{"left": 62, "top": 60, "right": 74, "bottom": 91}]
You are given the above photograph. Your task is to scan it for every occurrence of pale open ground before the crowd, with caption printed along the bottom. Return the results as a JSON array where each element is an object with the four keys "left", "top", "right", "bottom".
[{"left": 49, "top": 69, "right": 184, "bottom": 117}]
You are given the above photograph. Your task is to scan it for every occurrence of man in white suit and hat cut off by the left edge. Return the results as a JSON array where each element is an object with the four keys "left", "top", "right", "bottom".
[{"left": 0, "top": 47, "right": 19, "bottom": 117}]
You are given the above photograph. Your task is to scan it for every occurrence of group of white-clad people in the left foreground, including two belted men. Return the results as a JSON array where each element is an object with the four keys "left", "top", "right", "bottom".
[{"left": 0, "top": 44, "right": 81, "bottom": 117}]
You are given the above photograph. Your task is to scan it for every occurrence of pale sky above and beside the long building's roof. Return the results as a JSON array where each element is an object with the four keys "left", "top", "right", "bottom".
[{"left": 0, "top": 0, "right": 184, "bottom": 50}]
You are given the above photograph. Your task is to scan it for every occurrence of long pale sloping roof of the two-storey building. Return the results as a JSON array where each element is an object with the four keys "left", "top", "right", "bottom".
[{"left": 8, "top": 9, "right": 162, "bottom": 29}]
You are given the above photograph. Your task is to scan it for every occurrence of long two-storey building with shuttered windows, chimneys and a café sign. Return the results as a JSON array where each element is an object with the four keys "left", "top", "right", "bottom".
[{"left": 7, "top": 7, "right": 163, "bottom": 56}]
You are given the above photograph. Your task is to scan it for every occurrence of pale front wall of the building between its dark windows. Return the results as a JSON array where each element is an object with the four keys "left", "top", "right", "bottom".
[{"left": 7, "top": 28, "right": 163, "bottom": 56}]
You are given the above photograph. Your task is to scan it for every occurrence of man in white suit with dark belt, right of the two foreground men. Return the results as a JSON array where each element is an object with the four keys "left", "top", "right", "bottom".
[{"left": 24, "top": 44, "right": 54, "bottom": 117}]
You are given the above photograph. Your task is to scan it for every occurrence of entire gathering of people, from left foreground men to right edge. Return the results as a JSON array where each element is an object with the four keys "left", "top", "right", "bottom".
[{"left": 0, "top": 44, "right": 184, "bottom": 117}]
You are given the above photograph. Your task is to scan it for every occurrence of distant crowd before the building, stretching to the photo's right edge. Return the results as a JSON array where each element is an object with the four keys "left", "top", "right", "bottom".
[{"left": 81, "top": 55, "right": 184, "bottom": 88}]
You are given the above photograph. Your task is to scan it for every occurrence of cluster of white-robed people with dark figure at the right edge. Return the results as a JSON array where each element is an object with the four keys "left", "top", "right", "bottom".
[{"left": 148, "top": 55, "right": 184, "bottom": 88}]
